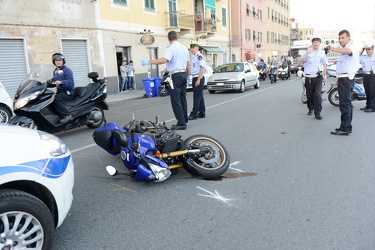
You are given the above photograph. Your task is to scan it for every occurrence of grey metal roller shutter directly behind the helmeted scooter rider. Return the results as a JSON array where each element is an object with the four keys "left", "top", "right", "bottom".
[{"left": 61, "top": 39, "right": 90, "bottom": 87}]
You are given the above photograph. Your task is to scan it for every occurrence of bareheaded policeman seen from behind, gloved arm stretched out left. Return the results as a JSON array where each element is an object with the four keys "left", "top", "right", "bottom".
[{"left": 141, "top": 31, "right": 190, "bottom": 130}]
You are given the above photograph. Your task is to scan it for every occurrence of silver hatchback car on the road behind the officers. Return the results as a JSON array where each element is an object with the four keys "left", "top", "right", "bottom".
[{"left": 207, "top": 62, "right": 260, "bottom": 94}]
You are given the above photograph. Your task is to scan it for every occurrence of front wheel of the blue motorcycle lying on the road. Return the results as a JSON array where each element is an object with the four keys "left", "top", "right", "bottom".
[{"left": 184, "top": 135, "right": 230, "bottom": 179}]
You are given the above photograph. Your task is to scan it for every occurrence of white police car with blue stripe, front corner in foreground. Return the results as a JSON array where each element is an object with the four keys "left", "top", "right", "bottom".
[{"left": 0, "top": 124, "right": 74, "bottom": 249}]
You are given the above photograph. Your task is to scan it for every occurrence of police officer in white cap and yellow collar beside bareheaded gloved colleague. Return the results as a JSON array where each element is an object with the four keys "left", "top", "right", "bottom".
[{"left": 188, "top": 41, "right": 206, "bottom": 120}]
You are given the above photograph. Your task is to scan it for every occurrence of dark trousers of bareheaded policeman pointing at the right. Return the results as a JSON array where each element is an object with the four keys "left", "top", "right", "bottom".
[{"left": 337, "top": 77, "right": 354, "bottom": 132}]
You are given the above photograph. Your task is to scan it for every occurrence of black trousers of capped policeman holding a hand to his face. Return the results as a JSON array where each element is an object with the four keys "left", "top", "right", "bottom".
[{"left": 305, "top": 76, "right": 323, "bottom": 115}]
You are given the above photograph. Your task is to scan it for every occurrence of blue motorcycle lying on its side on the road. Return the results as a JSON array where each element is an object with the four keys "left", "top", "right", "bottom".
[{"left": 93, "top": 117, "right": 230, "bottom": 182}]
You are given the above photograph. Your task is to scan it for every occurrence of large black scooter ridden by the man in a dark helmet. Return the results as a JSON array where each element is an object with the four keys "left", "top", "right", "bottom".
[{"left": 9, "top": 67, "right": 108, "bottom": 133}]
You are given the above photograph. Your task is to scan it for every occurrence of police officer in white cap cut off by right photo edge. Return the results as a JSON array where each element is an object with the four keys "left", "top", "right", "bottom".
[{"left": 359, "top": 45, "right": 375, "bottom": 112}]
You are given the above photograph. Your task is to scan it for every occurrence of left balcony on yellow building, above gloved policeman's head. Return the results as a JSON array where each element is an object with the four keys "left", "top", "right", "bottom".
[{"left": 165, "top": 11, "right": 194, "bottom": 36}]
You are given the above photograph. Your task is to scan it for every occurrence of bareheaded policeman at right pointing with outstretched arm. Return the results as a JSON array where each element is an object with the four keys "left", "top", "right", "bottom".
[{"left": 328, "top": 30, "right": 359, "bottom": 135}]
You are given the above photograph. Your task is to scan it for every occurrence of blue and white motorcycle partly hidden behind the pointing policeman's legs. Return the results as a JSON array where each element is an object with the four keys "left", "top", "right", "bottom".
[{"left": 327, "top": 77, "right": 366, "bottom": 107}]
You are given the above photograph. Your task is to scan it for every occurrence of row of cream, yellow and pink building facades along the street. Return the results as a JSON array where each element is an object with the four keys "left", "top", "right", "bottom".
[{"left": 0, "top": 0, "right": 289, "bottom": 96}]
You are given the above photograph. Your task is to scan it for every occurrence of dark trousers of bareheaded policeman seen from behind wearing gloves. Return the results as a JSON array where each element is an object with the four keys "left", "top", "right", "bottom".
[{"left": 170, "top": 72, "right": 188, "bottom": 126}]
